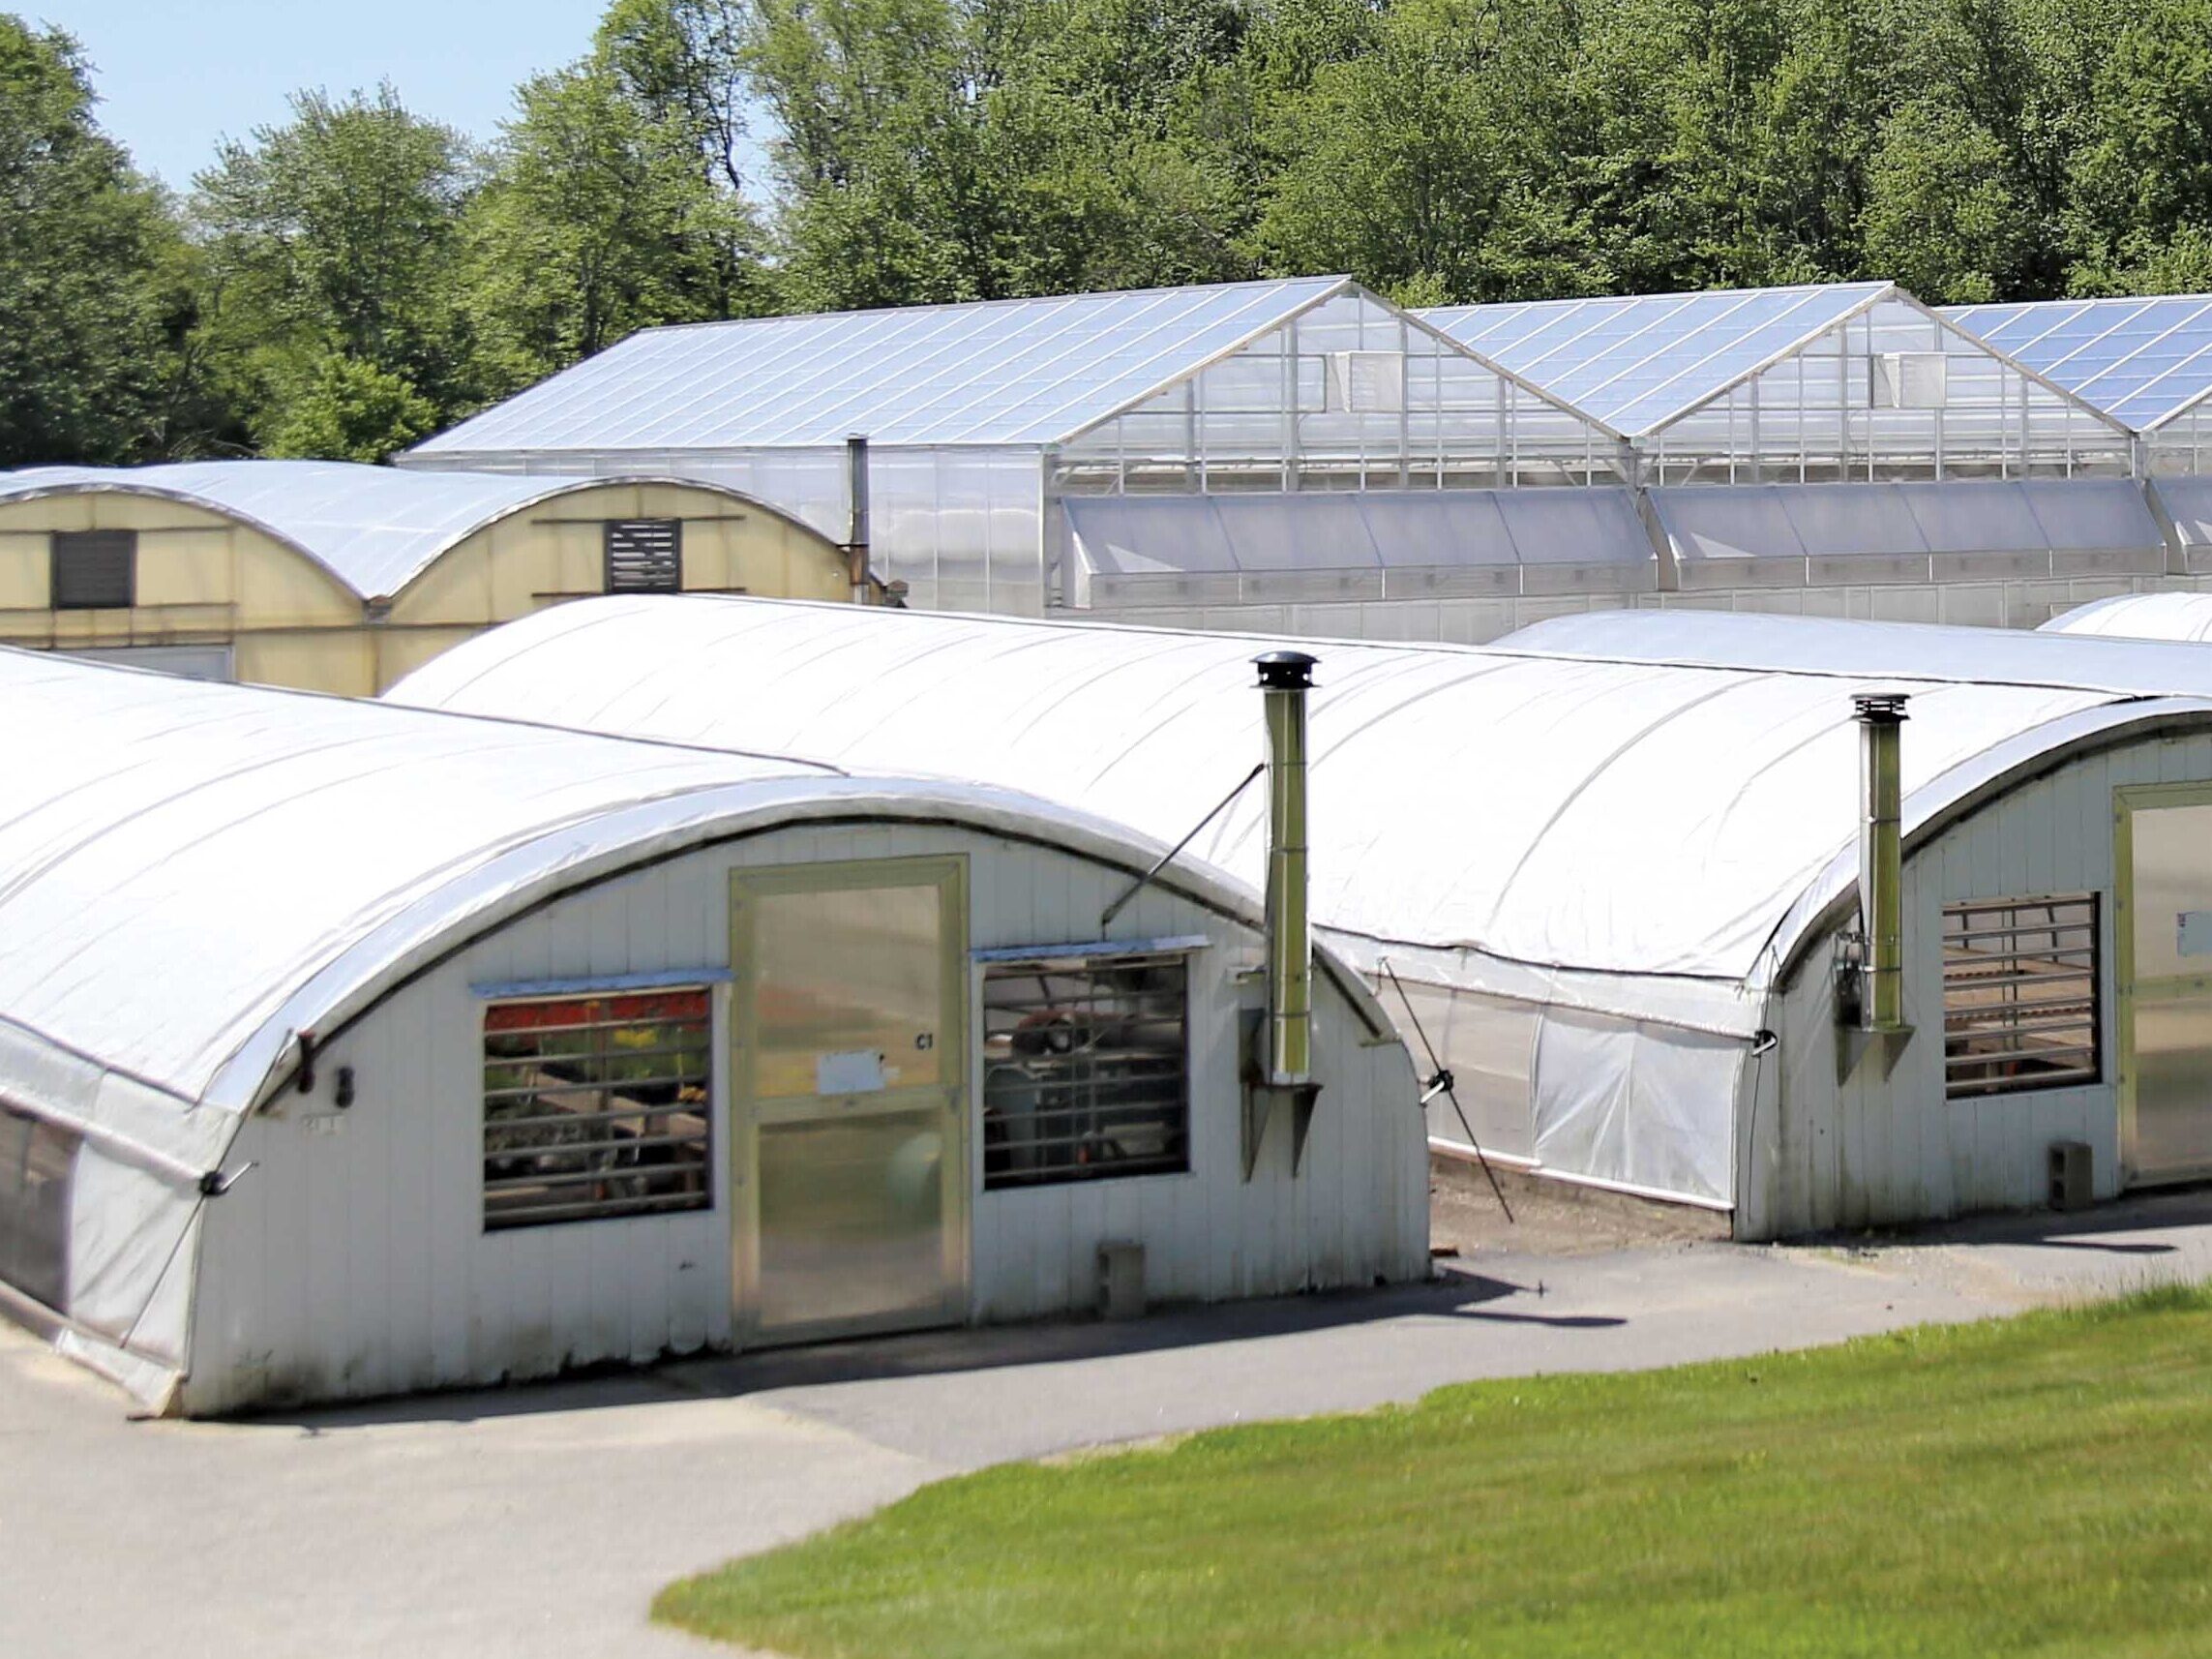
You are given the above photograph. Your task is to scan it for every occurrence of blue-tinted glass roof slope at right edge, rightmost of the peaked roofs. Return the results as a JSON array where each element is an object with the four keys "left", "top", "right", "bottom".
[{"left": 1944, "top": 294, "right": 2212, "bottom": 432}]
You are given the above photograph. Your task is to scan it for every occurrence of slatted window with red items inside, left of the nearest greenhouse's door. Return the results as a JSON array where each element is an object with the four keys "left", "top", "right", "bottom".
[{"left": 478, "top": 974, "right": 724, "bottom": 1237}]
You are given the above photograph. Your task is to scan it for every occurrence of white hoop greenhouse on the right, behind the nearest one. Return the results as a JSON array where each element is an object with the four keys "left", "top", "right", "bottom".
[{"left": 392, "top": 599, "right": 2212, "bottom": 1237}]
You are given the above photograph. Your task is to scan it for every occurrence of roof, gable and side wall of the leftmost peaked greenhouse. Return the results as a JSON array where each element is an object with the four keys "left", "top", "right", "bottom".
[{"left": 401, "top": 277, "right": 1622, "bottom": 615}]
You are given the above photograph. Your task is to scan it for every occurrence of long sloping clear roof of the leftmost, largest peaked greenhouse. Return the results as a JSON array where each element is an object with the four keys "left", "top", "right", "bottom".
[{"left": 416, "top": 277, "right": 1343, "bottom": 456}]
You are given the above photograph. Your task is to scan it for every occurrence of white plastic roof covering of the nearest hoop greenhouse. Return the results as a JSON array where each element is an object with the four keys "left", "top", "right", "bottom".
[{"left": 0, "top": 650, "right": 1292, "bottom": 1394}]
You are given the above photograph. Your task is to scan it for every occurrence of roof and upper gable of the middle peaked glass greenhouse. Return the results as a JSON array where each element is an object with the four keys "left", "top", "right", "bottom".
[{"left": 1418, "top": 284, "right": 2133, "bottom": 484}]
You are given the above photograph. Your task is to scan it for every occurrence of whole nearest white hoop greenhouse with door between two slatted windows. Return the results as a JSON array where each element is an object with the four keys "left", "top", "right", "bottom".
[{"left": 0, "top": 649, "right": 1429, "bottom": 1416}]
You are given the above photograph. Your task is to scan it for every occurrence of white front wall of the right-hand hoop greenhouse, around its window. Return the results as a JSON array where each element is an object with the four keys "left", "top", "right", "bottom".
[{"left": 1737, "top": 723, "right": 2212, "bottom": 1239}]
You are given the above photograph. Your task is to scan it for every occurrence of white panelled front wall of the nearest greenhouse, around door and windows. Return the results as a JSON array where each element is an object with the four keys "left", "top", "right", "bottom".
[{"left": 184, "top": 825, "right": 1429, "bottom": 1413}]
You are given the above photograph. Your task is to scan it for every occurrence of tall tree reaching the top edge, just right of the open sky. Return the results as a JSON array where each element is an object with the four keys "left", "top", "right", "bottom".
[{"left": 466, "top": 0, "right": 767, "bottom": 394}]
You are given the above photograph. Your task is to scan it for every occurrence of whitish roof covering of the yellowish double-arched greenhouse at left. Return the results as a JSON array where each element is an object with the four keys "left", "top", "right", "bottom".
[{"left": 0, "top": 460, "right": 783, "bottom": 599}]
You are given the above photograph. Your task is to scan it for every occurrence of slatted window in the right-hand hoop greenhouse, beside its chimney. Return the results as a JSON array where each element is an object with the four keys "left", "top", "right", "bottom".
[{"left": 1938, "top": 893, "right": 2106, "bottom": 1101}]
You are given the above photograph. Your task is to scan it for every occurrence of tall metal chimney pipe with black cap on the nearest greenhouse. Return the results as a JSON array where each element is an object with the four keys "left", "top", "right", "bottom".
[{"left": 1254, "top": 650, "right": 1314, "bottom": 1088}]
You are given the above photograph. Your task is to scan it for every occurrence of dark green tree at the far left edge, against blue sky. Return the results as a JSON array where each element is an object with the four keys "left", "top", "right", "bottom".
[{"left": 0, "top": 15, "right": 184, "bottom": 465}]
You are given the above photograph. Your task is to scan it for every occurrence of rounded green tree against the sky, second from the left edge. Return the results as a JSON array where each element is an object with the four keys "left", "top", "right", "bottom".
[{"left": 193, "top": 86, "right": 475, "bottom": 458}]
